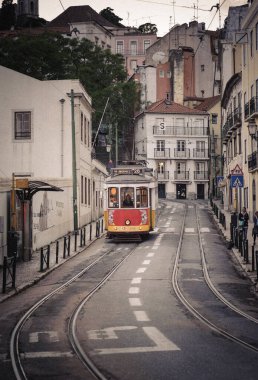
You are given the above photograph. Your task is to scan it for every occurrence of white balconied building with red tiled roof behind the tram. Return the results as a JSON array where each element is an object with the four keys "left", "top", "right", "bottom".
[{"left": 135, "top": 100, "right": 209, "bottom": 199}]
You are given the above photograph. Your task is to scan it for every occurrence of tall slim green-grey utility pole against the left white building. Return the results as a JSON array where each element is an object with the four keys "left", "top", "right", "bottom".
[{"left": 71, "top": 90, "right": 78, "bottom": 231}]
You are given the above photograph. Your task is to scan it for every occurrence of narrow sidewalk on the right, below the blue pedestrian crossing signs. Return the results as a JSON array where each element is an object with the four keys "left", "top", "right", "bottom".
[{"left": 210, "top": 200, "right": 258, "bottom": 292}]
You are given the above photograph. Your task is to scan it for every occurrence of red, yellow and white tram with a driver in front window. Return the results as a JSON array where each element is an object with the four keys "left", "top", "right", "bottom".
[{"left": 104, "top": 161, "right": 158, "bottom": 239}]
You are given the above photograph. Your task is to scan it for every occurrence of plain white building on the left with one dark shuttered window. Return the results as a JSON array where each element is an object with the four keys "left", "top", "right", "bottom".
[{"left": 0, "top": 66, "right": 106, "bottom": 262}]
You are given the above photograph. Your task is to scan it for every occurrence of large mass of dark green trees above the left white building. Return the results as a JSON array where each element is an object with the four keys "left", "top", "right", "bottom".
[{"left": 0, "top": 33, "right": 137, "bottom": 148}]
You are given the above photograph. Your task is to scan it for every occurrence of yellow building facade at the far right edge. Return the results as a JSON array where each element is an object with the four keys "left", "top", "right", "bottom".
[{"left": 242, "top": 0, "right": 258, "bottom": 215}]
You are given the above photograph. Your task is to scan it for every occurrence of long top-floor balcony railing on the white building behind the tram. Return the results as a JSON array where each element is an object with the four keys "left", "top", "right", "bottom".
[{"left": 153, "top": 125, "right": 209, "bottom": 136}]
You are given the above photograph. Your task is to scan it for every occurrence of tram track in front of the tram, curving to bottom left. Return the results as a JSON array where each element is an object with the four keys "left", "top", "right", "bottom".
[{"left": 9, "top": 242, "right": 139, "bottom": 380}]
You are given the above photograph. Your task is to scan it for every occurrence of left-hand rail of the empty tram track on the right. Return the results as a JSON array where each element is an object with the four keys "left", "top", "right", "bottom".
[{"left": 171, "top": 203, "right": 258, "bottom": 353}]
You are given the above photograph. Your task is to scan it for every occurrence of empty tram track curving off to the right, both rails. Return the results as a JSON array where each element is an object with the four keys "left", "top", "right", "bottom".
[{"left": 171, "top": 205, "right": 258, "bottom": 353}]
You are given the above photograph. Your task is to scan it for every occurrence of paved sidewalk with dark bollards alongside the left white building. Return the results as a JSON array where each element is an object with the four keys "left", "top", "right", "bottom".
[{"left": 0, "top": 222, "right": 104, "bottom": 303}]
